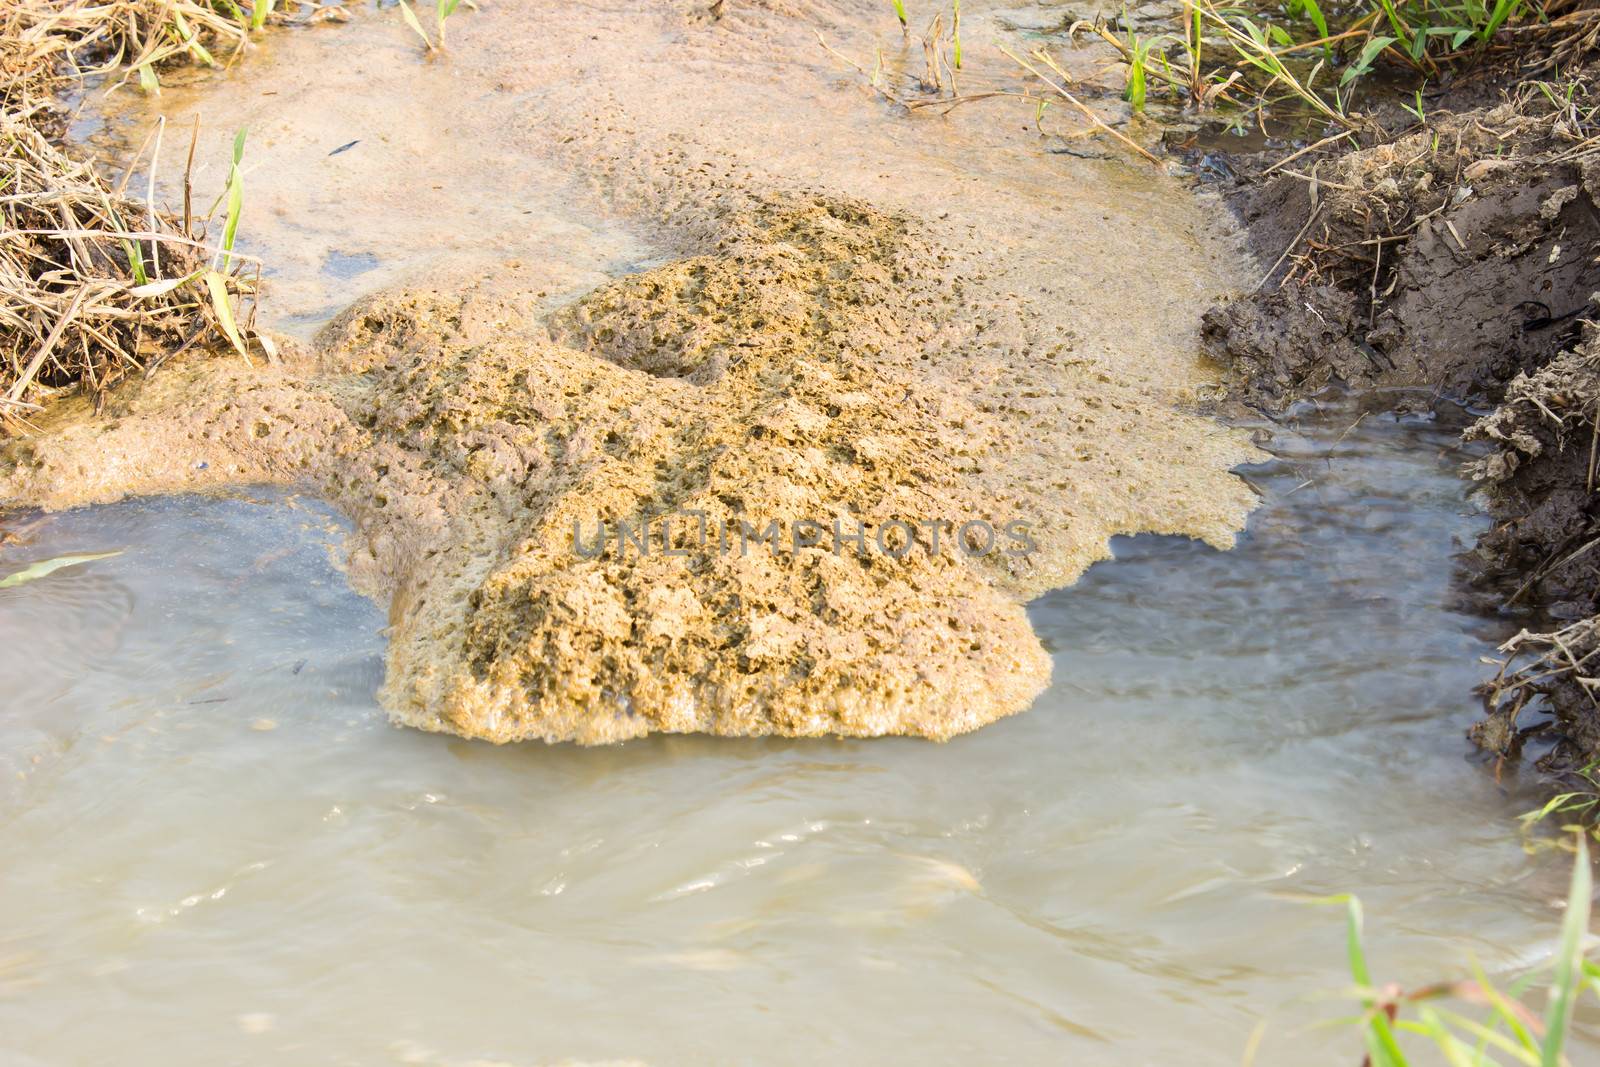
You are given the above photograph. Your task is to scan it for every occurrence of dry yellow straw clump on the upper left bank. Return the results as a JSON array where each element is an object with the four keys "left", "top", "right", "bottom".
[{"left": 0, "top": 0, "right": 344, "bottom": 430}]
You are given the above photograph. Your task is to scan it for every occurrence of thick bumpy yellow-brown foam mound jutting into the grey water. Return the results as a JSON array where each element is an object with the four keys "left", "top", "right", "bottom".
[{"left": 0, "top": 185, "right": 1248, "bottom": 744}]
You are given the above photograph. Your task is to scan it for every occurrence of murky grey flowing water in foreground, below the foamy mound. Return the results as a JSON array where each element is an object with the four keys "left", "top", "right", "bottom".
[{"left": 0, "top": 402, "right": 1600, "bottom": 1067}]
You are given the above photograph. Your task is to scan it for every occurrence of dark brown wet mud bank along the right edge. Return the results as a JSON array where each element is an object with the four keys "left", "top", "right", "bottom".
[{"left": 1205, "top": 67, "right": 1600, "bottom": 769}]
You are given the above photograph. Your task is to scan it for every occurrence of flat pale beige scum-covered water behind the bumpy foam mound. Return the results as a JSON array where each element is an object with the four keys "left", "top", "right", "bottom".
[{"left": 75, "top": 0, "right": 1235, "bottom": 371}]
